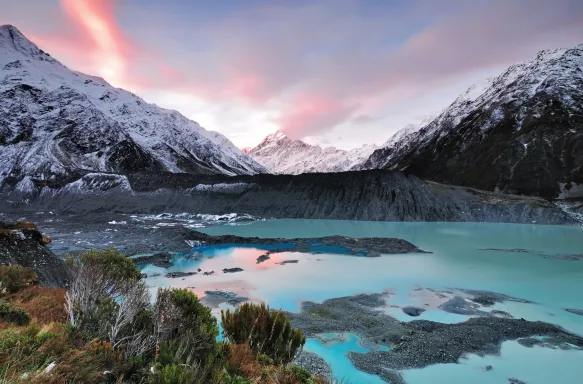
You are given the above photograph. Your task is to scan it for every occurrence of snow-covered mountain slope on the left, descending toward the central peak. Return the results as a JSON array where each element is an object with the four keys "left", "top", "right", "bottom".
[{"left": 0, "top": 25, "right": 265, "bottom": 189}]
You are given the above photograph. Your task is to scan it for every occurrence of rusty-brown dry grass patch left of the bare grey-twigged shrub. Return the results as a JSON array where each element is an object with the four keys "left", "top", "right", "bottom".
[{"left": 2, "top": 286, "right": 67, "bottom": 324}]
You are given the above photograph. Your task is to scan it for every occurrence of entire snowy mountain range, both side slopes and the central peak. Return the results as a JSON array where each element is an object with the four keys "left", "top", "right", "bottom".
[{"left": 0, "top": 25, "right": 583, "bottom": 202}]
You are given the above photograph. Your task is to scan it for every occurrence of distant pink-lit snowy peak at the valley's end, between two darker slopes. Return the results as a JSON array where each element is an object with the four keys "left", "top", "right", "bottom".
[{"left": 245, "top": 132, "right": 378, "bottom": 175}]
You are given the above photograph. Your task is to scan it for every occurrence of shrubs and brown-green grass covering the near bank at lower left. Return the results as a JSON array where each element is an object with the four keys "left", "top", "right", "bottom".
[{"left": 0, "top": 249, "right": 329, "bottom": 384}]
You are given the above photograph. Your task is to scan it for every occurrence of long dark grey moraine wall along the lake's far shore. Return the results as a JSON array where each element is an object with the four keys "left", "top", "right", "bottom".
[{"left": 0, "top": 170, "right": 577, "bottom": 224}]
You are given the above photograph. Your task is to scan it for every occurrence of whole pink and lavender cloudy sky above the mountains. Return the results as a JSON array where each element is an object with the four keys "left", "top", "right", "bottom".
[{"left": 0, "top": 0, "right": 583, "bottom": 149}]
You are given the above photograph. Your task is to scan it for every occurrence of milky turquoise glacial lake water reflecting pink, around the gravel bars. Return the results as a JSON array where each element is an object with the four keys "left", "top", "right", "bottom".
[{"left": 143, "top": 220, "right": 583, "bottom": 384}]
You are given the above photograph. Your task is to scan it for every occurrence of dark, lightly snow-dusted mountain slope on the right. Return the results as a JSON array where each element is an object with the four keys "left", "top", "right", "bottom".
[{"left": 357, "top": 45, "right": 583, "bottom": 198}]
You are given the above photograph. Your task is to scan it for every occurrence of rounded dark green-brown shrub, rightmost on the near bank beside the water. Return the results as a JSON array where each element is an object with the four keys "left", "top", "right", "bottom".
[{"left": 221, "top": 303, "right": 306, "bottom": 364}]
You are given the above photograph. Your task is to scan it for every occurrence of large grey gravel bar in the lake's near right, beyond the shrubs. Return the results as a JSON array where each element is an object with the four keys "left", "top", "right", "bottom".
[{"left": 287, "top": 291, "right": 583, "bottom": 384}]
